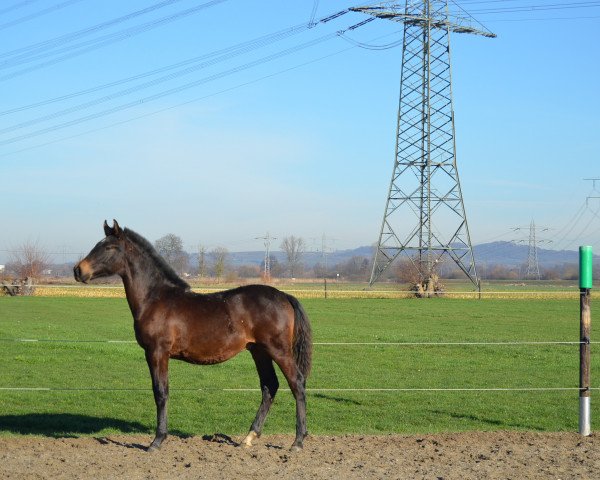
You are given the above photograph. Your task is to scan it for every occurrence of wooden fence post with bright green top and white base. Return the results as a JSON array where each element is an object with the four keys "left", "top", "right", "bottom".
[{"left": 579, "top": 246, "right": 592, "bottom": 436}]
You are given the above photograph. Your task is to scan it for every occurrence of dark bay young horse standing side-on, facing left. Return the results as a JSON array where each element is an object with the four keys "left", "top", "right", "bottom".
[{"left": 74, "top": 221, "right": 312, "bottom": 451}]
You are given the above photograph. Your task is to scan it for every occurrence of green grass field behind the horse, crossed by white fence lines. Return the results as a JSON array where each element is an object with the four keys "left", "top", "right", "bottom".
[{"left": 0, "top": 297, "right": 600, "bottom": 436}]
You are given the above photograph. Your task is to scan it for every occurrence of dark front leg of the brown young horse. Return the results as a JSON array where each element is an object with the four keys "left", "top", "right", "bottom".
[{"left": 146, "top": 349, "right": 169, "bottom": 452}]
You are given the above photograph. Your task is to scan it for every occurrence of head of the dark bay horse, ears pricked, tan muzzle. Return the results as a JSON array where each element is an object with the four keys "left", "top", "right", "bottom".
[{"left": 73, "top": 220, "right": 125, "bottom": 283}]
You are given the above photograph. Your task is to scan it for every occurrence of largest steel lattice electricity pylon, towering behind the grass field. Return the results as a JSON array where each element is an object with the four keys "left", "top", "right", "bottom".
[{"left": 351, "top": 0, "right": 495, "bottom": 287}]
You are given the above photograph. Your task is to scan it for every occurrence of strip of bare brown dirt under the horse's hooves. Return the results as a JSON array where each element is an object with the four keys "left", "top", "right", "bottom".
[{"left": 0, "top": 432, "right": 600, "bottom": 480}]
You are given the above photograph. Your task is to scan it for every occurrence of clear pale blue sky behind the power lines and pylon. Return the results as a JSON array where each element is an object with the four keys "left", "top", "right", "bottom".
[{"left": 0, "top": 0, "right": 600, "bottom": 261}]
